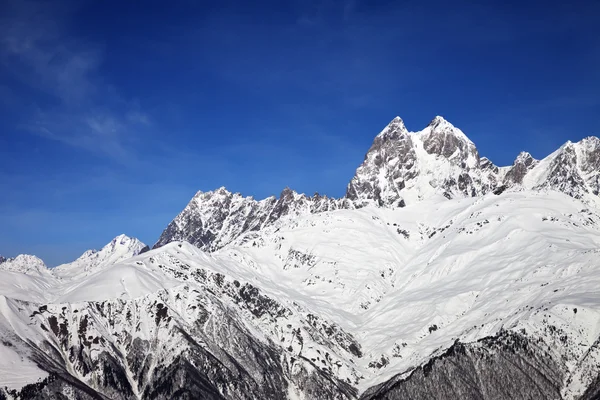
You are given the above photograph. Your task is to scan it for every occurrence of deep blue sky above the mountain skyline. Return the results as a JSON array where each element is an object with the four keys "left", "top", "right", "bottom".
[{"left": 0, "top": 0, "right": 600, "bottom": 265}]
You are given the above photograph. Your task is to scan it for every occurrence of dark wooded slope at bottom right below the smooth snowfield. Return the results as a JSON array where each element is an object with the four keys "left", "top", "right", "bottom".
[{"left": 361, "top": 333, "right": 565, "bottom": 400}]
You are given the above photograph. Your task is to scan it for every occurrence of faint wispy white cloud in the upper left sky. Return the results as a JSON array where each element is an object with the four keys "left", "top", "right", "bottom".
[{"left": 0, "top": 0, "right": 151, "bottom": 159}]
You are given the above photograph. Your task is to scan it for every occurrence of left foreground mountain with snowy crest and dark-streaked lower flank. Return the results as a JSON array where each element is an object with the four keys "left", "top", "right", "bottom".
[{"left": 0, "top": 243, "right": 357, "bottom": 399}]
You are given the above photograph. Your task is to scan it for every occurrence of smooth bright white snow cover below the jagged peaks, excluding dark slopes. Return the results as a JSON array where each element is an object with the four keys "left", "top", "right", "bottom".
[{"left": 0, "top": 191, "right": 600, "bottom": 397}]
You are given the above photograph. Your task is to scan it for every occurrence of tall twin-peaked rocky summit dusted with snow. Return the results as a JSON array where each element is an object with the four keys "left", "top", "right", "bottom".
[{"left": 346, "top": 116, "right": 497, "bottom": 207}]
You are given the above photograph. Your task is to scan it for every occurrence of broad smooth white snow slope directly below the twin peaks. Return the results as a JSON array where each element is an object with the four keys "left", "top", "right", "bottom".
[{"left": 214, "top": 192, "right": 600, "bottom": 396}]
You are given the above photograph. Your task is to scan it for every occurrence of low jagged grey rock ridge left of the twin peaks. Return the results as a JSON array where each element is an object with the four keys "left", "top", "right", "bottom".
[{"left": 154, "top": 187, "right": 354, "bottom": 251}]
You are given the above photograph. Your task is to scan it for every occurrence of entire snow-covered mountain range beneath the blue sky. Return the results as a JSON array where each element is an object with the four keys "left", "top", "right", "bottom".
[{"left": 0, "top": 117, "right": 600, "bottom": 399}]
